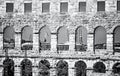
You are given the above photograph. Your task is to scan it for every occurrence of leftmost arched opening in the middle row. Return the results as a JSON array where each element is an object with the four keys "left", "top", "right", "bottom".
[{"left": 3, "top": 26, "right": 15, "bottom": 49}]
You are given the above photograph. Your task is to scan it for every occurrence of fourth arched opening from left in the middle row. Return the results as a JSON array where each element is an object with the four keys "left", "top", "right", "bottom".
[{"left": 57, "top": 26, "right": 69, "bottom": 50}]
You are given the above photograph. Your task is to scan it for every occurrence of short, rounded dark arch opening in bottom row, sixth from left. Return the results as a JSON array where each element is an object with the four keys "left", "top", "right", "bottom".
[{"left": 93, "top": 62, "right": 106, "bottom": 73}]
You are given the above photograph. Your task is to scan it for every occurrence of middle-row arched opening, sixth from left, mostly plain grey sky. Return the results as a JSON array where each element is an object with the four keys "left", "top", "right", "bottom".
[{"left": 94, "top": 26, "right": 107, "bottom": 49}]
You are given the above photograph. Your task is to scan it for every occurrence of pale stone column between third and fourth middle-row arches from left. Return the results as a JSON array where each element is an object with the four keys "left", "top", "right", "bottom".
[{"left": 51, "top": 34, "right": 57, "bottom": 53}]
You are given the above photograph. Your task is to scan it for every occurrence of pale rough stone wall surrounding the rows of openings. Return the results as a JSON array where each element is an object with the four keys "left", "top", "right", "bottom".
[{"left": 0, "top": 0, "right": 120, "bottom": 76}]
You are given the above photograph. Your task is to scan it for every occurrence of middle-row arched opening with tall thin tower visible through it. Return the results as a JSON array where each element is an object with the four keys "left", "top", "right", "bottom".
[{"left": 75, "top": 26, "right": 87, "bottom": 51}]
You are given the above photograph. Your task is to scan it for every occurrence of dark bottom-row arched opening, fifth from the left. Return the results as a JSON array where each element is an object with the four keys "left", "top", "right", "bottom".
[{"left": 75, "top": 61, "right": 87, "bottom": 76}]
